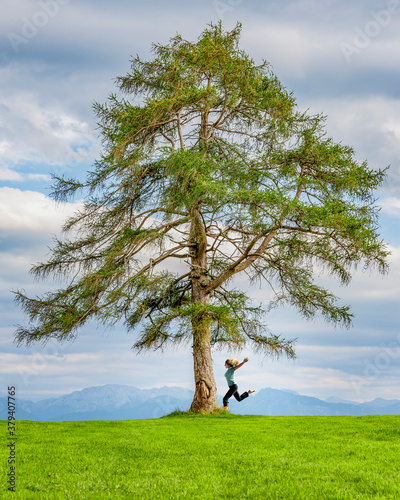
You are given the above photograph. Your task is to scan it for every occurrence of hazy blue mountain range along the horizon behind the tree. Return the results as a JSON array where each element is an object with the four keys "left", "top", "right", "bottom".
[{"left": 0, "top": 385, "right": 400, "bottom": 422}]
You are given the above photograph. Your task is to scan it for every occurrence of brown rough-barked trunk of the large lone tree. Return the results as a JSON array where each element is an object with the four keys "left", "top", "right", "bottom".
[{"left": 190, "top": 205, "right": 218, "bottom": 413}]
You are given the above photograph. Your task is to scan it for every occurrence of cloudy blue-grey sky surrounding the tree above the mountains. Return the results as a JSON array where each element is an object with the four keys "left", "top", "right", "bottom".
[{"left": 0, "top": 0, "right": 400, "bottom": 402}]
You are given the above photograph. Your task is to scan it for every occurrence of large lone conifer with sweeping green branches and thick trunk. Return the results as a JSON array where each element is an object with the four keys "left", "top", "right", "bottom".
[{"left": 16, "top": 23, "right": 388, "bottom": 411}]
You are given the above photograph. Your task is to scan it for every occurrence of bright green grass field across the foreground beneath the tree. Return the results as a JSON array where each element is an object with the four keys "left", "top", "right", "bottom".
[{"left": 0, "top": 412, "right": 400, "bottom": 500}]
